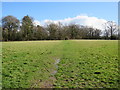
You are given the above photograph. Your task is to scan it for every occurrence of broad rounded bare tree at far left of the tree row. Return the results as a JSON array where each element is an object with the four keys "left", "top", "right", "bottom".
[{"left": 2, "top": 15, "right": 20, "bottom": 40}]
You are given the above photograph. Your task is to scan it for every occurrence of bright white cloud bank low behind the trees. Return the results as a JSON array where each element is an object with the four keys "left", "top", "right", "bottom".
[{"left": 35, "top": 15, "right": 107, "bottom": 30}]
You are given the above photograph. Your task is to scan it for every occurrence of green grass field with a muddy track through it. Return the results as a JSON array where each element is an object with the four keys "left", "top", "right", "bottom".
[{"left": 2, "top": 40, "right": 119, "bottom": 88}]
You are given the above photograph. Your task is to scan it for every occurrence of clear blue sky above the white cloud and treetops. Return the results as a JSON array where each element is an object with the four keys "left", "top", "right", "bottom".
[{"left": 2, "top": 2, "right": 118, "bottom": 21}]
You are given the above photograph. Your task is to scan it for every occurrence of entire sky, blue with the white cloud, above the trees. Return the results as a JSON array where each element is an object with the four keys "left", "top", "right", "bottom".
[{"left": 2, "top": 2, "right": 118, "bottom": 29}]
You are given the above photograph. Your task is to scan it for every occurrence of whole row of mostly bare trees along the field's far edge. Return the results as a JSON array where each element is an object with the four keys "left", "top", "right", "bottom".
[{"left": 0, "top": 15, "right": 118, "bottom": 41}]
